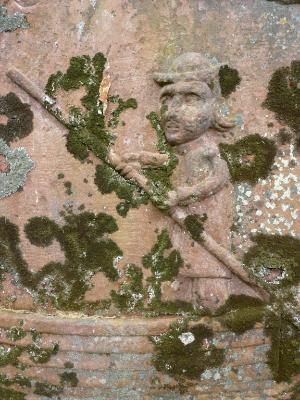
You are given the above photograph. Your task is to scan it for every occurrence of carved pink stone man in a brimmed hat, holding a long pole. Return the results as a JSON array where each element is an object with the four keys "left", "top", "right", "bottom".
[{"left": 116, "top": 53, "right": 257, "bottom": 308}]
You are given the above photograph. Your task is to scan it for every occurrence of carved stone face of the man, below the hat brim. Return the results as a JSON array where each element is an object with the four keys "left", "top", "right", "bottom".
[{"left": 160, "top": 82, "right": 215, "bottom": 145}]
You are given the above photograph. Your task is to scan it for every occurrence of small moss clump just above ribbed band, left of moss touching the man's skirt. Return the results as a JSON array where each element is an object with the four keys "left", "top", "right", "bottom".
[{"left": 111, "top": 264, "right": 145, "bottom": 311}]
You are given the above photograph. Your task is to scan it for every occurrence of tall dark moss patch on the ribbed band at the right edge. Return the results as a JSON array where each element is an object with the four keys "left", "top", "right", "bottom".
[{"left": 265, "top": 306, "right": 300, "bottom": 382}]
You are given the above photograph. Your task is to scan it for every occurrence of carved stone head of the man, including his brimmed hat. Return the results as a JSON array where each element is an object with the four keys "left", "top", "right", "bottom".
[{"left": 154, "top": 53, "right": 232, "bottom": 145}]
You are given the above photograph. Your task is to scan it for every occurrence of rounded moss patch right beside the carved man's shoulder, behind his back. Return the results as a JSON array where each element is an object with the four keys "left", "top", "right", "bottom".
[{"left": 219, "top": 134, "right": 277, "bottom": 184}]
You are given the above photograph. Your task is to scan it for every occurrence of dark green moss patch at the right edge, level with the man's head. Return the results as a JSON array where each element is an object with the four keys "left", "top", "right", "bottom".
[{"left": 263, "top": 60, "right": 300, "bottom": 144}]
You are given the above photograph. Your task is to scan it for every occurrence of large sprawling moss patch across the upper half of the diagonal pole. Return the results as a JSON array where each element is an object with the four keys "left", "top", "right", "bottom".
[{"left": 45, "top": 53, "right": 143, "bottom": 217}]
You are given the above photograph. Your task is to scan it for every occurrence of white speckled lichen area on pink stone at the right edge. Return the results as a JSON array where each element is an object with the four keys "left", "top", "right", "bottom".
[{"left": 232, "top": 144, "right": 300, "bottom": 250}]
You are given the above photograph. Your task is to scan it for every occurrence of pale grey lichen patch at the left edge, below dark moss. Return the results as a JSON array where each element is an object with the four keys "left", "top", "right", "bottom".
[{"left": 0, "top": 139, "right": 34, "bottom": 198}]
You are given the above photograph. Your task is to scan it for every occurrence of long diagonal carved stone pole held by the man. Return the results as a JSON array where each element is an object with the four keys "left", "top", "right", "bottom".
[{"left": 7, "top": 69, "right": 270, "bottom": 301}]
